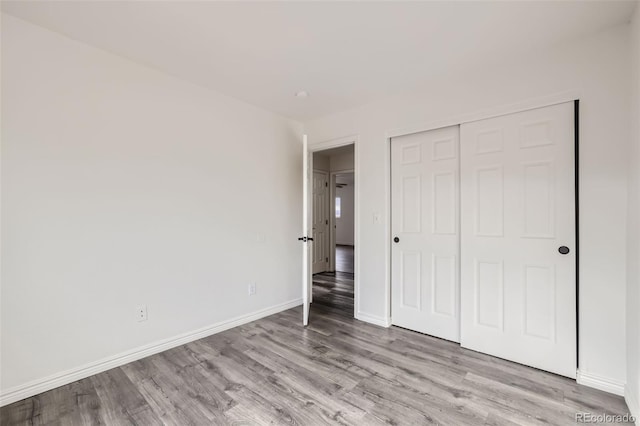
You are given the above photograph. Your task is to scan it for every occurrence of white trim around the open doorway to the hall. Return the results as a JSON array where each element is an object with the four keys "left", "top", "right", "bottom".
[{"left": 307, "top": 134, "right": 358, "bottom": 321}]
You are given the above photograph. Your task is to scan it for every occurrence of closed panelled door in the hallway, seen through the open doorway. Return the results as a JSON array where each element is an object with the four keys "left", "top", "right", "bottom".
[{"left": 312, "top": 170, "right": 329, "bottom": 274}]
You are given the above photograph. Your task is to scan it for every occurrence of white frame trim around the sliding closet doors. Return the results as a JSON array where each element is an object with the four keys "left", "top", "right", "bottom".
[{"left": 382, "top": 91, "right": 582, "bottom": 369}]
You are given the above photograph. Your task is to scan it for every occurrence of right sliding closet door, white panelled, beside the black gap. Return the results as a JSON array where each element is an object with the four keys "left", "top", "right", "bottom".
[{"left": 460, "top": 103, "right": 576, "bottom": 378}]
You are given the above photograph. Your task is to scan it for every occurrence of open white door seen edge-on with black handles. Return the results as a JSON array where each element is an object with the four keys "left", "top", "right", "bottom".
[{"left": 298, "top": 135, "right": 313, "bottom": 326}]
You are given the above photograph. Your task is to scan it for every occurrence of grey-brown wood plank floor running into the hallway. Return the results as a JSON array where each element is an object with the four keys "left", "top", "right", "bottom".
[{"left": 0, "top": 273, "right": 627, "bottom": 426}]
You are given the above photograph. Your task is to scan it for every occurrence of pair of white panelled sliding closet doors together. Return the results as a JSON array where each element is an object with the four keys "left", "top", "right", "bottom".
[{"left": 391, "top": 102, "right": 577, "bottom": 378}]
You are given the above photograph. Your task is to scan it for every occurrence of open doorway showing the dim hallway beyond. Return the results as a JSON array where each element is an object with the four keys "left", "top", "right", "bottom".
[{"left": 311, "top": 144, "right": 356, "bottom": 317}]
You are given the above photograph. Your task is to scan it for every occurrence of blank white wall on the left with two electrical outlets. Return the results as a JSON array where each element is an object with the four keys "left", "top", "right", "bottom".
[{"left": 0, "top": 15, "right": 302, "bottom": 402}]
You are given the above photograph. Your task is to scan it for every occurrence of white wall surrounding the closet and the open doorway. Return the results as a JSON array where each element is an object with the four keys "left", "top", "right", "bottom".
[{"left": 305, "top": 22, "right": 630, "bottom": 392}]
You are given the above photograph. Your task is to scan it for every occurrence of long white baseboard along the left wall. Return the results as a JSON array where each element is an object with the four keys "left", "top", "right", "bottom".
[{"left": 0, "top": 299, "right": 302, "bottom": 407}]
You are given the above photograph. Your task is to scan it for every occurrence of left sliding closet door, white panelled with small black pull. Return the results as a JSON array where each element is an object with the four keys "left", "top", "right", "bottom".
[{"left": 391, "top": 126, "right": 460, "bottom": 342}]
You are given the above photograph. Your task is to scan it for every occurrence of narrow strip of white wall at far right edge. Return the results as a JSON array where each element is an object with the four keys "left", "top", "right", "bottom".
[{"left": 626, "top": 5, "right": 640, "bottom": 425}]
